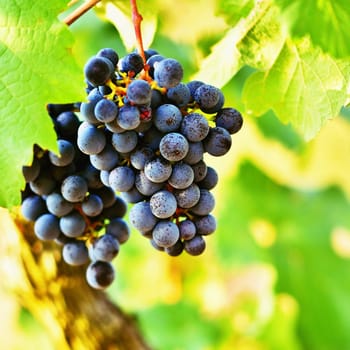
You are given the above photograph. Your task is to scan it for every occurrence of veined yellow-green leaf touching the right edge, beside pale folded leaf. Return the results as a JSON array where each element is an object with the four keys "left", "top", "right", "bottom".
[{"left": 243, "top": 39, "right": 350, "bottom": 140}]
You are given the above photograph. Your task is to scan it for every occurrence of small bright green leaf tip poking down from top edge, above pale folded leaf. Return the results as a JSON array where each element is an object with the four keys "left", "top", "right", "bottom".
[{"left": 217, "top": 0, "right": 255, "bottom": 25}]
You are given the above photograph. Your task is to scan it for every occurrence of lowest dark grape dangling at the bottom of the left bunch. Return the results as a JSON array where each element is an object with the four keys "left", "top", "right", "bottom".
[{"left": 86, "top": 261, "right": 115, "bottom": 289}]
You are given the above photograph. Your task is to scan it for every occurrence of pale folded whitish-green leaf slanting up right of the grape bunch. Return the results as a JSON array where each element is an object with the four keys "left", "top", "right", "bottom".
[{"left": 192, "top": 0, "right": 285, "bottom": 87}]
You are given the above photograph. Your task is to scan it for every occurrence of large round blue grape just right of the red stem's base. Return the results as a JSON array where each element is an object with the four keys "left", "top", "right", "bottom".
[{"left": 154, "top": 58, "right": 183, "bottom": 89}]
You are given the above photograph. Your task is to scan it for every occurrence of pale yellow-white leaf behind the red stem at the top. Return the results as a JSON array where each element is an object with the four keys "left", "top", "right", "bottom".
[{"left": 98, "top": 0, "right": 158, "bottom": 52}]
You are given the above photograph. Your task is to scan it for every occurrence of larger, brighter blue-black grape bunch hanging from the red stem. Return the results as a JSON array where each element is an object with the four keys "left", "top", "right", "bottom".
[{"left": 78, "top": 48, "right": 243, "bottom": 256}]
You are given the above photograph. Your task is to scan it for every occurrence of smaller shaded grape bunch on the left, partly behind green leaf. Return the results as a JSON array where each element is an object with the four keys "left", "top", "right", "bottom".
[{"left": 21, "top": 104, "right": 129, "bottom": 289}]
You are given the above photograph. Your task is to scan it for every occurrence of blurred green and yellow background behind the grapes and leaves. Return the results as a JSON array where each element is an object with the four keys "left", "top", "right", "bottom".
[{"left": 0, "top": 0, "right": 350, "bottom": 350}]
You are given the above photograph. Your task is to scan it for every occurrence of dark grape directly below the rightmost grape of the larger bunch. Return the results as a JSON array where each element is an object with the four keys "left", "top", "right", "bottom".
[{"left": 204, "top": 126, "right": 232, "bottom": 157}]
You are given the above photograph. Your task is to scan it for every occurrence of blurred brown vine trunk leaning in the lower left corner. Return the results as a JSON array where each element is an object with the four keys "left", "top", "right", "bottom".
[{"left": 0, "top": 208, "right": 150, "bottom": 350}]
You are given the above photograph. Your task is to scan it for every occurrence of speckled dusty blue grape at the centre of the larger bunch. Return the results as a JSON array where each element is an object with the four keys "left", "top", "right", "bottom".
[{"left": 159, "top": 132, "right": 189, "bottom": 162}]
